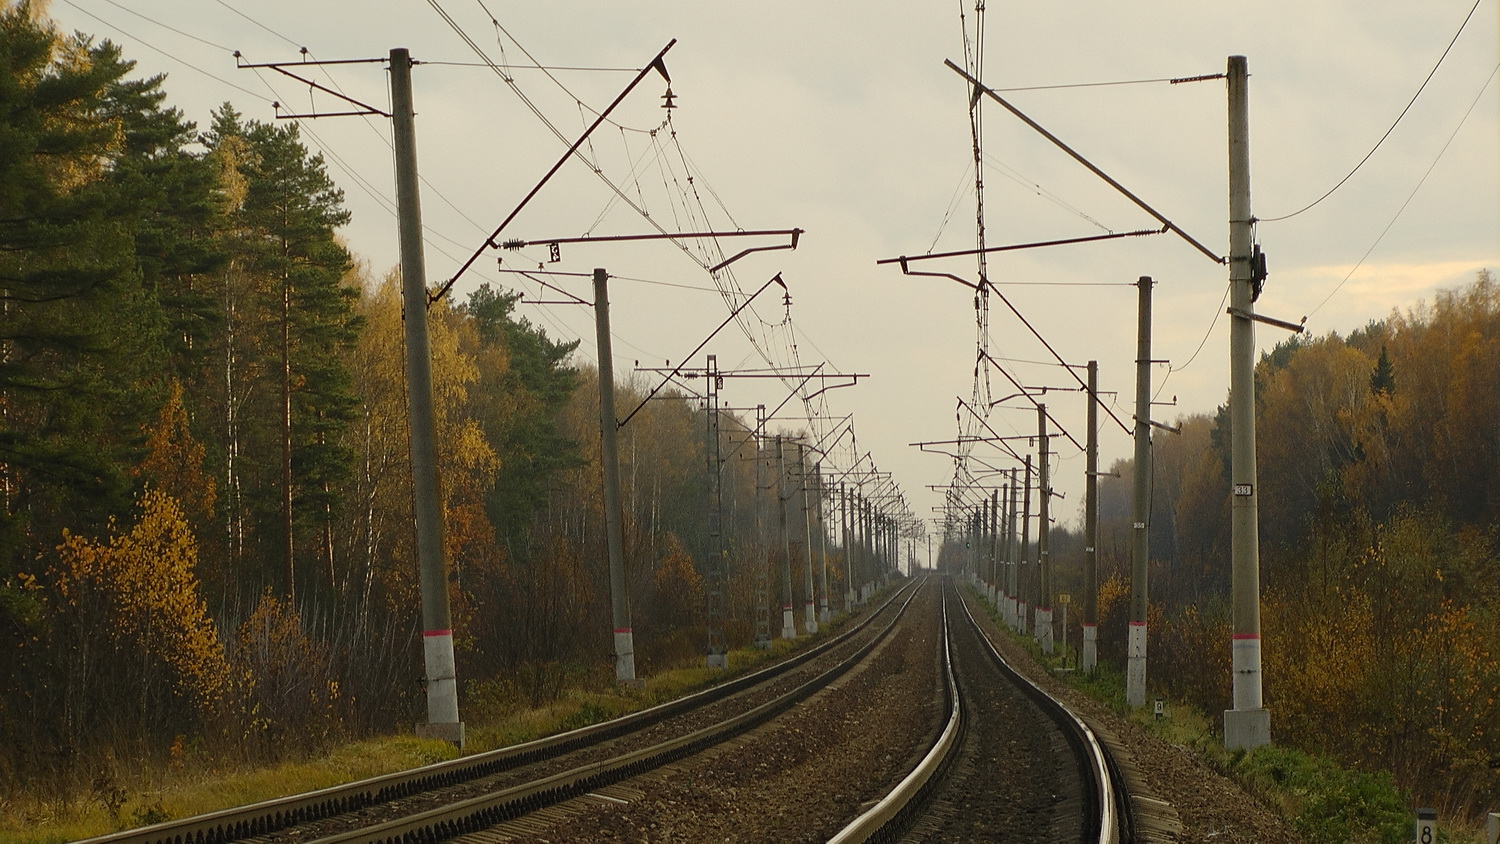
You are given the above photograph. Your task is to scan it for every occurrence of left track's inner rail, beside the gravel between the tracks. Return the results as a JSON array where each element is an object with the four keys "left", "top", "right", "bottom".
[{"left": 306, "top": 579, "right": 926, "bottom": 844}]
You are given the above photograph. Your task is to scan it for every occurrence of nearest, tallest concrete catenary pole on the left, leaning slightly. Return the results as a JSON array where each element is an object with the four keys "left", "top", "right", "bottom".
[{"left": 390, "top": 46, "right": 464, "bottom": 747}]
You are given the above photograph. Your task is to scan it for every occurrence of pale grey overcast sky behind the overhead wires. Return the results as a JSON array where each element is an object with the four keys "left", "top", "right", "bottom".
[{"left": 51, "top": 0, "right": 1500, "bottom": 560}]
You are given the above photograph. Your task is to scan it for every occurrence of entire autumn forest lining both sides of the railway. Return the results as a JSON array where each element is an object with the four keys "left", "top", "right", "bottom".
[{"left": 0, "top": 3, "right": 1500, "bottom": 814}]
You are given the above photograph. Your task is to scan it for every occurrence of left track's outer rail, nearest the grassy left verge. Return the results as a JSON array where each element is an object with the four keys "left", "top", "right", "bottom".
[{"left": 78, "top": 583, "right": 915, "bottom": 844}]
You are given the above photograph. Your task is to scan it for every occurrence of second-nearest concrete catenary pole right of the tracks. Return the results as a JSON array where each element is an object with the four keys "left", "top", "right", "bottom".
[{"left": 1125, "top": 276, "right": 1152, "bottom": 706}]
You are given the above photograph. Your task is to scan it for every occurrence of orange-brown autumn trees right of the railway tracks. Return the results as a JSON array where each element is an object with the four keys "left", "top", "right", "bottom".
[{"left": 1086, "top": 271, "right": 1500, "bottom": 813}]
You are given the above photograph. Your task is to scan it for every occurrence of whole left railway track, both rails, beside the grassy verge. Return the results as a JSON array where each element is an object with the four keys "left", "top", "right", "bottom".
[{"left": 86, "top": 583, "right": 920, "bottom": 844}]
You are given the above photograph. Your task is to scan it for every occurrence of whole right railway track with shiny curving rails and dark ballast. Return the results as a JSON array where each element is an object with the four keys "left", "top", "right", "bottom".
[{"left": 831, "top": 583, "right": 1133, "bottom": 844}]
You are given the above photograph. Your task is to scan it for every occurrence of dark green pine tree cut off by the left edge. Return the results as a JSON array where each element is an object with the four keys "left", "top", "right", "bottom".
[{"left": 0, "top": 3, "right": 159, "bottom": 559}]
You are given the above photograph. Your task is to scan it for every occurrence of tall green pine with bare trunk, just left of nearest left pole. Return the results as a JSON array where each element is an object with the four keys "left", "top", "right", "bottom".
[{"left": 206, "top": 106, "right": 359, "bottom": 595}]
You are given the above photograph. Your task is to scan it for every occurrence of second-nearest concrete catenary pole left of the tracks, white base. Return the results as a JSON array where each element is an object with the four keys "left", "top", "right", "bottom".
[{"left": 594, "top": 268, "right": 636, "bottom": 684}]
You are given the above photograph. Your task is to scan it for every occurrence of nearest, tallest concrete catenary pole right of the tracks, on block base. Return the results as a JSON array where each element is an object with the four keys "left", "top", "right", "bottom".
[{"left": 1224, "top": 55, "right": 1271, "bottom": 748}]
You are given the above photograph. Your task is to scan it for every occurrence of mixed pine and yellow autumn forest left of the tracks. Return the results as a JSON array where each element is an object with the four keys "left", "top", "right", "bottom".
[{"left": 0, "top": 1, "right": 870, "bottom": 790}]
